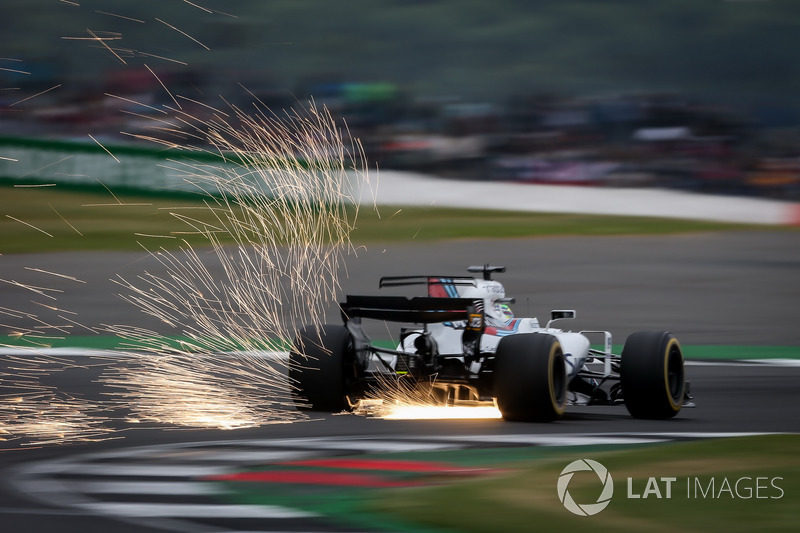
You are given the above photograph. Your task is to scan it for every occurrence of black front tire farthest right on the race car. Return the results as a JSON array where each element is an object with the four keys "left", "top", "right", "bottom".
[{"left": 619, "top": 331, "right": 686, "bottom": 420}]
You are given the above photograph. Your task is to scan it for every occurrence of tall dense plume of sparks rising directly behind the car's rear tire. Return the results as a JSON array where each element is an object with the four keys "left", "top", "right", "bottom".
[{"left": 100, "top": 100, "right": 366, "bottom": 428}]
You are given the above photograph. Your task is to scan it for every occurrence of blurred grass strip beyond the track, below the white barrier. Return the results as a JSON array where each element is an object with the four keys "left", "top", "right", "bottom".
[{"left": 0, "top": 184, "right": 780, "bottom": 254}]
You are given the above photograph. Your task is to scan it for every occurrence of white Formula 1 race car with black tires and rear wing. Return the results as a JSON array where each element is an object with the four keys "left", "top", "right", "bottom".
[{"left": 289, "top": 265, "right": 693, "bottom": 421}]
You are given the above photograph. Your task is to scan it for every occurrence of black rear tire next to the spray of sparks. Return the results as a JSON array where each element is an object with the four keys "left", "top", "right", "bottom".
[{"left": 289, "top": 325, "right": 354, "bottom": 413}]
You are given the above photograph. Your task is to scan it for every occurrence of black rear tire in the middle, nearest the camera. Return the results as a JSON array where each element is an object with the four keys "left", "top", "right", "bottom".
[{"left": 494, "top": 333, "right": 567, "bottom": 422}]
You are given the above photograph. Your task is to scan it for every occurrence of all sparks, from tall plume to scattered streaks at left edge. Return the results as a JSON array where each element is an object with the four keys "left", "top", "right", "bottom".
[{"left": 0, "top": 91, "right": 368, "bottom": 438}]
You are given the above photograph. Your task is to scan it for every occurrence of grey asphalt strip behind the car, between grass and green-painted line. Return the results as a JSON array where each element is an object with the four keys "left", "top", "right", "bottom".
[{"left": 0, "top": 230, "right": 800, "bottom": 340}]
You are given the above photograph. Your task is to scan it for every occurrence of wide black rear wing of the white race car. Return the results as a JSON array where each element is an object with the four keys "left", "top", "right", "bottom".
[{"left": 340, "top": 295, "right": 483, "bottom": 324}]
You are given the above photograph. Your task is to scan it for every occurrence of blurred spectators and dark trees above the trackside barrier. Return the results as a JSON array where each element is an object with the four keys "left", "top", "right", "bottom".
[{"left": 0, "top": 0, "right": 800, "bottom": 200}]
